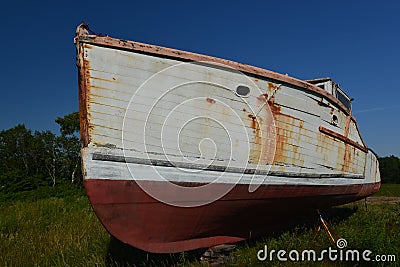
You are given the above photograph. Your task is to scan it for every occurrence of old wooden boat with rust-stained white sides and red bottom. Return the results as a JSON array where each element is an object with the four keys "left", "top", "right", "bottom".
[{"left": 74, "top": 24, "right": 380, "bottom": 253}]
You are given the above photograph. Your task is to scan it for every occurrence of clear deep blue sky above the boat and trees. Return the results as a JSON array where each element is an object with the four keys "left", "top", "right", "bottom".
[{"left": 0, "top": 1, "right": 400, "bottom": 156}]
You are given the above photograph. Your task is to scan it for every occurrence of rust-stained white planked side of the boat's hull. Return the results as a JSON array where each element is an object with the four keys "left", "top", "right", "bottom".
[{"left": 79, "top": 44, "right": 379, "bottom": 186}]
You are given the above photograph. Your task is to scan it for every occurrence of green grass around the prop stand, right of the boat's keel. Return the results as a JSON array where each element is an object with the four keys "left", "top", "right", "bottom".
[{"left": 231, "top": 203, "right": 400, "bottom": 266}]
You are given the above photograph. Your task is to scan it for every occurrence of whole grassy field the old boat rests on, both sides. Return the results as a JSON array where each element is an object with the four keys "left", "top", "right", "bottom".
[{"left": 0, "top": 185, "right": 400, "bottom": 266}]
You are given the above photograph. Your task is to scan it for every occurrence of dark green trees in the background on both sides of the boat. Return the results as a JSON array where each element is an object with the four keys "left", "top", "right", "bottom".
[{"left": 0, "top": 112, "right": 400, "bottom": 193}]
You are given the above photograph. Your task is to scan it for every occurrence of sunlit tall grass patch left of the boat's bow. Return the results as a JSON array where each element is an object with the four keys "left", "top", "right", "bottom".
[{"left": 0, "top": 193, "right": 109, "bottom": 266}]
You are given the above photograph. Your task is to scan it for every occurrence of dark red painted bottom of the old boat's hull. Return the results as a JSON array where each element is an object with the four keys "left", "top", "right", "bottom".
[{"left": 85, "top": 179, "right": 380, "bottom": 253}]
